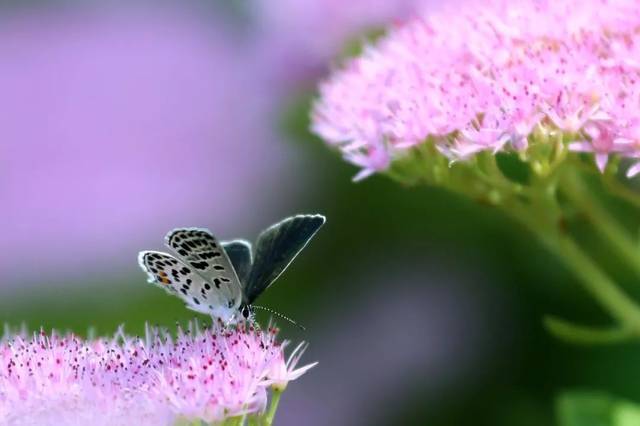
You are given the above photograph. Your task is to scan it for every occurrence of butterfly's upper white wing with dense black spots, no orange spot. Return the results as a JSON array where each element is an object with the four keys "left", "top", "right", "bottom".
[{"left": 165, "top": 228, "right": 242, "bottom": 307}]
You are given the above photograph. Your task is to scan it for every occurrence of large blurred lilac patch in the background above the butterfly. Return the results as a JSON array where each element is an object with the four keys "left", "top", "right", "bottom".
[{"left": 0, "top": 4, "right": 296, "bottom": 285}]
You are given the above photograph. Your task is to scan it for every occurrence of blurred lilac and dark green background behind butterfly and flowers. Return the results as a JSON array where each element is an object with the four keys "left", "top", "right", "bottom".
[{"left": 0, "top": 0, "right": 640, "bottom": 426}]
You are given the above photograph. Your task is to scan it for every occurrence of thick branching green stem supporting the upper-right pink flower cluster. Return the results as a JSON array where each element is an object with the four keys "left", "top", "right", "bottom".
[{"left": 404, "top": 147, "right": 640, "bottom": 342}]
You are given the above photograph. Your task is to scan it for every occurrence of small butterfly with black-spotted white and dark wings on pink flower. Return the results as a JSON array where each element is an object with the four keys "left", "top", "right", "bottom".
[{"left": 138, "top": 214, "right": 326, "bottom": 323}]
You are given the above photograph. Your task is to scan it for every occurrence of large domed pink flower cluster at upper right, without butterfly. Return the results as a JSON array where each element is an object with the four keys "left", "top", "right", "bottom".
[{"left": 312, "top": 0, "right": 640, "bottom": 178}]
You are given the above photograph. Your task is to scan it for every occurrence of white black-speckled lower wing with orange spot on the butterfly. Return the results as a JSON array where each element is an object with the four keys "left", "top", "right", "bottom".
[{"left": 138, "top": 251, "right": 235, "bottom": 318}]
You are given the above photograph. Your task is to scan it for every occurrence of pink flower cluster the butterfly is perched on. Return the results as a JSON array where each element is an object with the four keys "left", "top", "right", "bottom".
[{"left": 0, "top": 325, "right": 313, "bottom": 426}]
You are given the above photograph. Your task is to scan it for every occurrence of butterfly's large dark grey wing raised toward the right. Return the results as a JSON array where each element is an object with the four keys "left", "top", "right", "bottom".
[{"left": 244, "top": 214, "right": 326, "bottom": 304}]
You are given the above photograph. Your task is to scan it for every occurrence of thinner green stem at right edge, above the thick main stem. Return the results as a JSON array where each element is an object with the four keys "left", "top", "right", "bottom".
[{"left": 564, "top": 171, "right": 640, "bottom": 275}]
